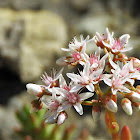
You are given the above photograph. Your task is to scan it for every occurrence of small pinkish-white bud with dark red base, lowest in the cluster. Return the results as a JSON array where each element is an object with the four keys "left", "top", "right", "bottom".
[{"left": 57, "top": 111, "right": 68, "bottom": 125}]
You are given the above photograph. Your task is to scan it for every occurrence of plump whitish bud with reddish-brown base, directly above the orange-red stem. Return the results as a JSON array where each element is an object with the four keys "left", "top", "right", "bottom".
[{"left": 103, "top": 97, "right": 118, "bottom": 112}]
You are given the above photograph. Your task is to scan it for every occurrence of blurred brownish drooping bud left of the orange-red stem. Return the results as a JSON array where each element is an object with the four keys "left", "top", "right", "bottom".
[{"left": 92, "top": 105, "right": 101, "bottom": 121}]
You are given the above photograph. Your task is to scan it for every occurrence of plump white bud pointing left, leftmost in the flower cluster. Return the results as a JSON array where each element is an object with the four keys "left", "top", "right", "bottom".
[{"left": 26, "top": 83, "right": 45, "bottom": 97}]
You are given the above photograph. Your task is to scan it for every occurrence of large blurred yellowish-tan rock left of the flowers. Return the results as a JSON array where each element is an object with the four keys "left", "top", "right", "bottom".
[{"left": 0, "top": 9, "right": 68, "bottom": 82}]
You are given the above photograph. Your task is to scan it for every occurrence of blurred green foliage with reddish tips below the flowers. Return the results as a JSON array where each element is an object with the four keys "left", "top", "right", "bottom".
[{"left": 15, "top": 105, "right": 93, "bottom": 140}]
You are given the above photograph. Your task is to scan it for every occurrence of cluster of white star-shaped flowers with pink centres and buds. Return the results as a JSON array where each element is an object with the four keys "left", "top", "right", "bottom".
[{"left": 26, "top": 28, "right": 140, "bottom": 125}]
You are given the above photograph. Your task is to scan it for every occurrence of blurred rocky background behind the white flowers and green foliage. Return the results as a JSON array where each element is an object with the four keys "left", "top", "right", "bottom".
[{"left": 0, "top": 0, "right": 140, "bottom": 140}]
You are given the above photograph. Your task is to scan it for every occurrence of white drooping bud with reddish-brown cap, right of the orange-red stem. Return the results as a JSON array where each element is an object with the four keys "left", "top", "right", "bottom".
[{"left": 121, "top": 98, "right": 133, "bottom": 115}]
